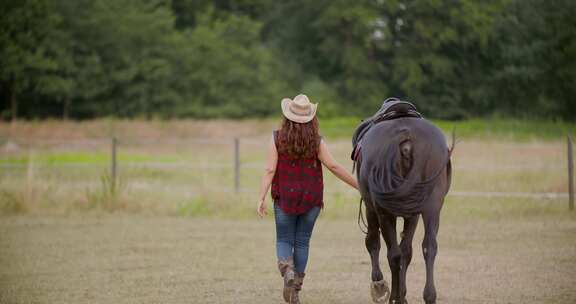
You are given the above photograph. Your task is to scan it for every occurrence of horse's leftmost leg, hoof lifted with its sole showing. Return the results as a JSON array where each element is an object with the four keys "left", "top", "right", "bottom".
[{"left": 365, "top": 204, "right": 390, "bottom": 303}]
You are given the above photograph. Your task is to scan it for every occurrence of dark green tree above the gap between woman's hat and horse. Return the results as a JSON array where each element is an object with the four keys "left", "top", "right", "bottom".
[{"left": 264, "top": 0, "right": 388, "bottom": 114}]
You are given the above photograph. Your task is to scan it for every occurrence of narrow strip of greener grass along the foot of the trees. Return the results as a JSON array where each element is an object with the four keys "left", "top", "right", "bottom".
[{"left": 0, "top": 117, "right": 576, "bottom": 141}]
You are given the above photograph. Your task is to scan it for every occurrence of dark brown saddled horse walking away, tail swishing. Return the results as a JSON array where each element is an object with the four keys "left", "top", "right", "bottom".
[{"left": 352, "top": 98, "right": 455, "bottom": 304}]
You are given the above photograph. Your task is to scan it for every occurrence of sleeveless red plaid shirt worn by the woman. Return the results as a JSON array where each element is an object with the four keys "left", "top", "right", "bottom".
[{"left": 271, "top": 132, "right": 324, "bottom": 214}]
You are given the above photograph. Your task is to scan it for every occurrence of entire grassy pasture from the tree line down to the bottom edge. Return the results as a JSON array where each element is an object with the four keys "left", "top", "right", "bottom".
[{"left": 0, "top": 120, "right": 576, "bottom": 303}]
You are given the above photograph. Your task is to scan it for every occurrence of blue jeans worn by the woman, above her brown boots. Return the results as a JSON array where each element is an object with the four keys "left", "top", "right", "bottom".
[{"left": 274, "top": 204, "right": 320, "bottom": 273}]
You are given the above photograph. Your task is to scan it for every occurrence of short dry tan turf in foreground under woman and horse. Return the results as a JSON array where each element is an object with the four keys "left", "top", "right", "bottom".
[{"left": 0, "top": 213, "right": 576, "bottom": 304}]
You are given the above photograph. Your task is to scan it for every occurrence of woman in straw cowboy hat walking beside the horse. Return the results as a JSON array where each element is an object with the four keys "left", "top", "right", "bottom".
[{"left": 257, "top": 95, "right": 358, "bottom": 303}]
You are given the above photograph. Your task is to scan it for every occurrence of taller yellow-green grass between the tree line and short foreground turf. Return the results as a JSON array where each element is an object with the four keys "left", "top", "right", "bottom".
[{"left": 0, "top": 118, "right": 574, "bottom": 218}]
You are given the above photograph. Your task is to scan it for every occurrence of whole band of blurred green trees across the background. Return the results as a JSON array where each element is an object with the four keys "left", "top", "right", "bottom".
[{"left": 0, "top": 0, "right": 576, "bottom": 121}]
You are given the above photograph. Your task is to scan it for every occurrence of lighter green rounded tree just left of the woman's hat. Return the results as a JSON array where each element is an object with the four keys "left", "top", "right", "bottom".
[{"left": 171, "top": 8, "right": 289, "bottom": 117}]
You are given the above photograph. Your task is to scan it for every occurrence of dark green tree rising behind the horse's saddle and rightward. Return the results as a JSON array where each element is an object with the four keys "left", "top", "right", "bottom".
[{"left": 382, "top": 0, "right": 501, "bottom": 119}]
